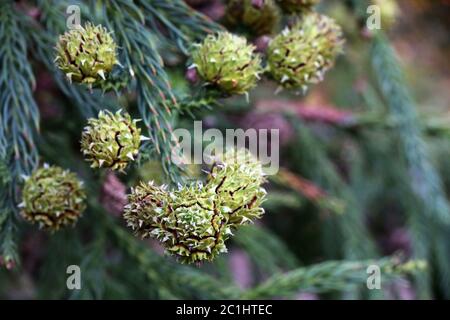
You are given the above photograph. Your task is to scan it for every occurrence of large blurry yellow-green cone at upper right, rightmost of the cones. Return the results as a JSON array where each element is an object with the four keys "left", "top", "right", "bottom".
[{"left": 267, "top": 13, "right": 344, "bottom": 90}]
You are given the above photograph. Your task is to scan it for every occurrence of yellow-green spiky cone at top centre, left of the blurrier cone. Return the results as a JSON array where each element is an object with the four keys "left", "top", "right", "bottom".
[{"left": 192, "top": 32, "right": 262, "bottom": 94}]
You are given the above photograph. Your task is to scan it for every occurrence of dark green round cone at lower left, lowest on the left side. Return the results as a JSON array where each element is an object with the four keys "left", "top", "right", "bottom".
[{"left": 20, "top": 166, "right": 86, "bottom": 230}]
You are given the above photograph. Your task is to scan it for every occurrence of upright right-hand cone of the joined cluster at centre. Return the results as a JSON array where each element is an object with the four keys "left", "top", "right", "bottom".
[{"left": 205, "top": 149, "right": 266, "bottom": 227}]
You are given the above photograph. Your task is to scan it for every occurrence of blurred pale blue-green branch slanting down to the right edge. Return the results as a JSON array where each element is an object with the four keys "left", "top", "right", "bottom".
[{"left": 372, "top": 34, "right": 450, "bottom": 225}]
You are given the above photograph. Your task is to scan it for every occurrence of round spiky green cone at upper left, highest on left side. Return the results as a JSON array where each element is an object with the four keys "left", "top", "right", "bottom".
[{"left": 55, "top": 23, "right": 118, "bottom": 85}]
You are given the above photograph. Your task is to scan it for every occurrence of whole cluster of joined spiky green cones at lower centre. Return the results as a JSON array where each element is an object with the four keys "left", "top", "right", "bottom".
[{"left": 124, "top": 149, "right": 265, "bottom": 263}]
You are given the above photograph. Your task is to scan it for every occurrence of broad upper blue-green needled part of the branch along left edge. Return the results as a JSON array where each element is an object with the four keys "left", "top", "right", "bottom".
[{"left": 0, "top": 2, "right": 39, "bottom": 183}]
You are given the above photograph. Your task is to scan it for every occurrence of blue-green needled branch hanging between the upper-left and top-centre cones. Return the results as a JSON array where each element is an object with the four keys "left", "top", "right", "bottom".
[{"left": 96, "top": 0, "right": 188, "bottom": 182}]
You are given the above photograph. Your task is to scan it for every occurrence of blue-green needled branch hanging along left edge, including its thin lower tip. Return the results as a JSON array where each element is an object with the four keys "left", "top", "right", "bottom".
[{"left": 0, "top": 1, "right": 39, "bottom": 263}]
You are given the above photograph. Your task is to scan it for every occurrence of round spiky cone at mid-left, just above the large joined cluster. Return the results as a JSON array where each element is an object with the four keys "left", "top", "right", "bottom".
[{"left": 81, "top": 110, "right": 142, "bottom": 171}]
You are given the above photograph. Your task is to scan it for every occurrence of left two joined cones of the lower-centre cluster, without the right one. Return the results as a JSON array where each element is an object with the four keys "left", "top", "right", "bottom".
[{"left": 124, "top": 182, "right": 231, "bottom": 263}]
